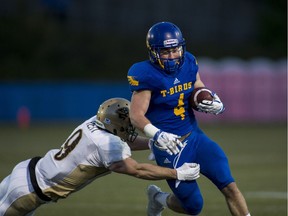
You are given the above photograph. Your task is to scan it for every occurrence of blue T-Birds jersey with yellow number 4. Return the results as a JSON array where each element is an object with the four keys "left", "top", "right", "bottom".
[{"left": 128, "top": 52, "right": 198, "bottom": 136}]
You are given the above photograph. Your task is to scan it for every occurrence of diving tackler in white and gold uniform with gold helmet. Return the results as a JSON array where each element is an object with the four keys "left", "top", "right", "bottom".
[{"left": 0, "top": 98, "right": 200, "bottom": 216}]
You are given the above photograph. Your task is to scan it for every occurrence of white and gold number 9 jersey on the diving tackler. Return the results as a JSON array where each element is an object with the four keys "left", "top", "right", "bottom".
[{"left": 35, "top": 116, "right": 131, "bottom": 200}]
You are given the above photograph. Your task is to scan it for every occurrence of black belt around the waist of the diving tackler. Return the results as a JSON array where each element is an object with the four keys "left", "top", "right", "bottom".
[{"left": 28, "top": 157, "right": 52, "bottom": 202}]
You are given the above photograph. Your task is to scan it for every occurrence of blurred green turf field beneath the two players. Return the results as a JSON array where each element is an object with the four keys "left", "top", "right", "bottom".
[{"left": 0, "top": 122, "right": 287, "bottom": 216}]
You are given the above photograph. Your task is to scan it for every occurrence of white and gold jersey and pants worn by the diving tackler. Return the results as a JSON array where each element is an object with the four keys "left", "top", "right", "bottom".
[{"left": 0, "top": 116, "right": 131, "bottom": 216}]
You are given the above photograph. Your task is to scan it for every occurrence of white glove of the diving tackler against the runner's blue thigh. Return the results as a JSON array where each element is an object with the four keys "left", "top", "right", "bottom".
[{"left": 176, "top": 163, "right": 200, "bottom": 181}]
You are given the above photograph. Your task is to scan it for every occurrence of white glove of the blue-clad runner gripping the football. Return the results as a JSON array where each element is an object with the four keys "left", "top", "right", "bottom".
[{"left": 197, "top": 92, "right": 225, "bottom": 115}]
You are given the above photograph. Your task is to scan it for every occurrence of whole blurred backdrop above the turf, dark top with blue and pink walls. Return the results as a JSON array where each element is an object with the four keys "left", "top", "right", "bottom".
[{"left": 0, "top": 0, "right": 287, "bottom": 123}]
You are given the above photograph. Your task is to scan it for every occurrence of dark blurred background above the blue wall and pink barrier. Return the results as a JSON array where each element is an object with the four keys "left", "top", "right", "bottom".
[{"left": 0, "top": 0, "right": 287, "bottom": 81}]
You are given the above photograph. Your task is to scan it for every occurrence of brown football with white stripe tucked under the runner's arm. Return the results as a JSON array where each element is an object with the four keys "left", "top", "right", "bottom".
[{"left": 189, "top": 87, "right": 213, "bottom": 110}]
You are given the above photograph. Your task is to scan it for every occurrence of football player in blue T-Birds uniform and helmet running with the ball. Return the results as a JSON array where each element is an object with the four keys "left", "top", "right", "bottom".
[{"left": 128, "top": 22, "right": 250, "bottom": 216}]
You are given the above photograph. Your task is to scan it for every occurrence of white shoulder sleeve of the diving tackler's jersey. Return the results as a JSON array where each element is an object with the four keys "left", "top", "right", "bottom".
[{"left": 98, "top": 136, "right": 131, "bottom": 168}]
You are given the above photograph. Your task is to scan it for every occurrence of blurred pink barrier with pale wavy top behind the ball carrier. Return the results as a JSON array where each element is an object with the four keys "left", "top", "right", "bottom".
[{"left": 198, "top": 58, "right": 287, "bottom": 122}]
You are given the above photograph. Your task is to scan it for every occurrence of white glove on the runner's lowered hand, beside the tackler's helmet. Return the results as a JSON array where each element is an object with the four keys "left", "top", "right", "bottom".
[{"left": 153, "top": 130, "right": 184, "bottom": 155}]
